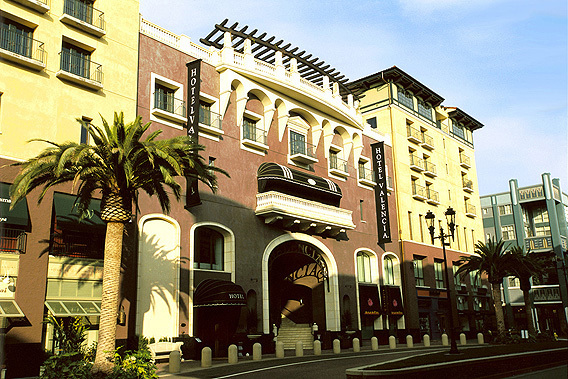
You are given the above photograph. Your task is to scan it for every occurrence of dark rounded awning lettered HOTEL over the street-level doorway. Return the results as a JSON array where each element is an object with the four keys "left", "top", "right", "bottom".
[{"left": 193, "top": 279, "right": 247, "bottom": 307}]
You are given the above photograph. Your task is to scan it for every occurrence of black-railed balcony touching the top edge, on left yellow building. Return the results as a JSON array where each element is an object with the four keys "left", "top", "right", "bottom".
[{"left": 59, "top": 0, "right": 106, "bottom": 38}]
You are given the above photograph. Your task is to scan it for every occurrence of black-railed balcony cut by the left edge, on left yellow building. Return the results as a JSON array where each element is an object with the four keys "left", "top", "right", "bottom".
[{"left": 0, "top": 25, "right": 46, "bottom": 71}]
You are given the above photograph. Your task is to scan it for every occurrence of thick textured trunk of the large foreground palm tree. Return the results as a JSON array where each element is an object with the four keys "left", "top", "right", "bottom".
[{"left": 92, "top": 221, "right": 124, "bottom": 373}]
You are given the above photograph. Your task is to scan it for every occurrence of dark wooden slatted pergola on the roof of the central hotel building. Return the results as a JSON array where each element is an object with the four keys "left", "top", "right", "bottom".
[{"left": 200, "top": 19, "right": 352, "bottom": 95}]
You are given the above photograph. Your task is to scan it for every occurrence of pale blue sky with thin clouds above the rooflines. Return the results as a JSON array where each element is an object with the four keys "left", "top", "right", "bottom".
[{"left": 140, "top": 0, "right": 568, "bottom": 195}]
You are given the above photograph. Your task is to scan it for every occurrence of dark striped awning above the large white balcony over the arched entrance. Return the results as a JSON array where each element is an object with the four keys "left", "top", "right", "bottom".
[{"left": 257, "top": 162, "right": 342, "bottom": 207}]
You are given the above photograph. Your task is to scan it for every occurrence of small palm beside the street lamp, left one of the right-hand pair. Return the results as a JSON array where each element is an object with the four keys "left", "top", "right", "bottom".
[{"left": 455, "top": 239, "right": 508, "bottom": 340}]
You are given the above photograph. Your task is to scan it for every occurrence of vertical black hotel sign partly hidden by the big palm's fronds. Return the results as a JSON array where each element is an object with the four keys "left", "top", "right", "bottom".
[{"left": 185, "top": 59, "right": 201, "bottom": 208}]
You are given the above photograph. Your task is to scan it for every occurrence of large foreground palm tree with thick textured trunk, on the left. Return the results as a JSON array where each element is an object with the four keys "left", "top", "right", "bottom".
[{"left": 11, "top": 112, "right": 226, "bottom": 373}]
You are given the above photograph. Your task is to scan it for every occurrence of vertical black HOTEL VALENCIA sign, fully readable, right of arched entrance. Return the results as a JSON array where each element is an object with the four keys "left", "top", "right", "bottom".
[{"left": 371, "top": 142, "right": 391, "bottom": 244}]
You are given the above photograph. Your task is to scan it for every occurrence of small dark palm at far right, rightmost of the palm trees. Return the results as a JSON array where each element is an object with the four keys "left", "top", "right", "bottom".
[{"left": 508, "top": 246, "right": 544, "bottom": 338}]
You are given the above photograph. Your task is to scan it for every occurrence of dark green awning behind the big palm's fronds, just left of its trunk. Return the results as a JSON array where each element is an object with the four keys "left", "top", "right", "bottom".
[{"left": 53, "top": 192, "right": 106, "bottom": 228}]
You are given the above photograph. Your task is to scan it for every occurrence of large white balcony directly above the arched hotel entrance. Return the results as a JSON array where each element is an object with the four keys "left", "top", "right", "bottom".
[{"left": 255, "top": 191, "right": 355, "bottom": 237}]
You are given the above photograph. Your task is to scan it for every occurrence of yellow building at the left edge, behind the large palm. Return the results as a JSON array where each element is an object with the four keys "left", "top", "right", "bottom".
[{"left": 0, "top": 0, "right": 140, "bottom": 377}]
